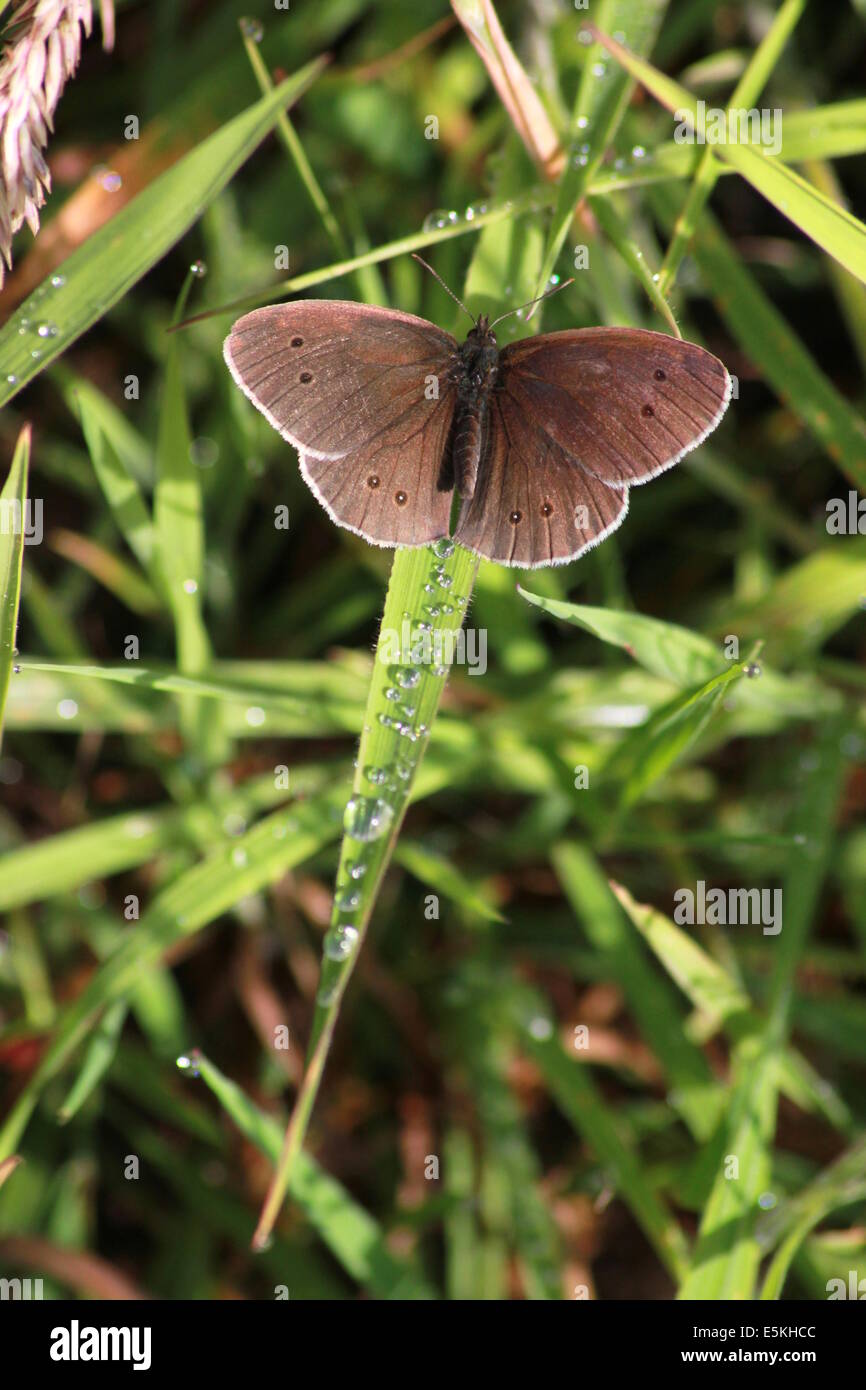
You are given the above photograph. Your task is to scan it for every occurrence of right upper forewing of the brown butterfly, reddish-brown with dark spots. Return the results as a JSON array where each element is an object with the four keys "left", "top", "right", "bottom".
[{"left": 499, "top": 328, "right": 731, "bottom": 488}]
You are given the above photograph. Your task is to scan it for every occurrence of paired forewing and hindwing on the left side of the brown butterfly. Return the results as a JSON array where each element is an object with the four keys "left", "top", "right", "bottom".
[{"left": 224, "top": 300, "right": 457, "bottom": 545}]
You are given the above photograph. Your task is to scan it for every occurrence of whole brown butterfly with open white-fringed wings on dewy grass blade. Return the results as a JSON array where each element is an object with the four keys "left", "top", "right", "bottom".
[{"left": 224, "top": 267, "right": 731, "bottom": 569}]
